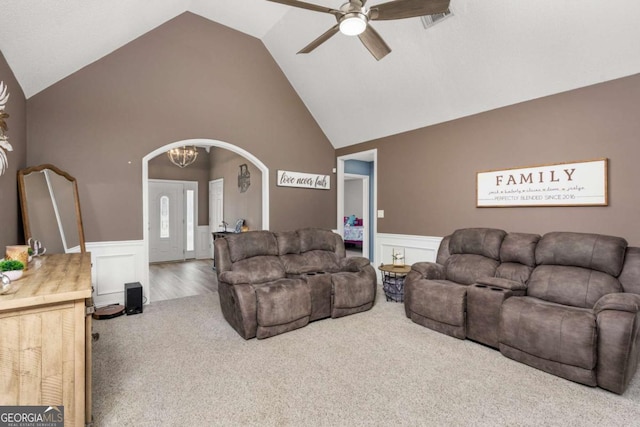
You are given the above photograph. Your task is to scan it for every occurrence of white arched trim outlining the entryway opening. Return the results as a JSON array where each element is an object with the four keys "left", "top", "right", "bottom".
[{"left": 142, "top": 138, "right": 269, "bottom": 302}]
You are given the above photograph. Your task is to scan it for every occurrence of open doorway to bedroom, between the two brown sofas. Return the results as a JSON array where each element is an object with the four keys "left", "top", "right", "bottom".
[{"left": 336, "top": 150, "right": 377, "bottom": 261}]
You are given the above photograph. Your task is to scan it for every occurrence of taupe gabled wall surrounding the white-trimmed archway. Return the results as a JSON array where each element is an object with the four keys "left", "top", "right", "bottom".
[{"left": 27, "top": 13, "right": 336, "bottom": 242}]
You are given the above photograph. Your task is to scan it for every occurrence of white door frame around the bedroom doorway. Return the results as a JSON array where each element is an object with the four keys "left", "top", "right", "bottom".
[{"left": 336, "top": 148, "right": 378, "bottom": 265}]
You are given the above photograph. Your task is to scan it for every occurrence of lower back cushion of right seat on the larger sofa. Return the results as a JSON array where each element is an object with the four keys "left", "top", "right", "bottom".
[{"left": 527, "top": 265, "right": 622, "bottom": 308}]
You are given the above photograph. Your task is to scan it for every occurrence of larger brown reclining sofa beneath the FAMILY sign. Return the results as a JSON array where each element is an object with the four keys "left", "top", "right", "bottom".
[{"left": 405, "top": 228, "right": 640, "bottom": 394}]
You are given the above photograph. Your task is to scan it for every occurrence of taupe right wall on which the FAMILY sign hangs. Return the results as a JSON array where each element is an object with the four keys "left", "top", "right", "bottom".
[{"left": 337, "top": 74, "right": 640, "bottom": 245}]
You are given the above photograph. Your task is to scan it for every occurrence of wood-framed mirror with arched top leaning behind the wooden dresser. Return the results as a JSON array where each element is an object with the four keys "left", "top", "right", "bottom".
[{"left": 18, "top": 164, "right": 86, "bottom": 254}]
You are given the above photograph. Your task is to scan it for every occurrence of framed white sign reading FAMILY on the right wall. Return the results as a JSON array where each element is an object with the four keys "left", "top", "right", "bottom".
[{"left": 476, "top": 159, "right": 609, "bottom": 208}]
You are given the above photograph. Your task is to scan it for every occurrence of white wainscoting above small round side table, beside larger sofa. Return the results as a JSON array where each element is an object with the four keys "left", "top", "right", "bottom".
[{"left": 373, "top": 233, "right": 442, "bottom": 280}]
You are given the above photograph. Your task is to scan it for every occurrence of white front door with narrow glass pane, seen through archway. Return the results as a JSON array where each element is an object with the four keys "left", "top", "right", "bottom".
[{"left": 149, "top": 180, "right": 185, "bottom": 262}]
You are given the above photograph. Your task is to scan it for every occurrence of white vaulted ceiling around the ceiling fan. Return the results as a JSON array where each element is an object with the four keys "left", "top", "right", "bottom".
[{"left": 0, "top": 0, "right": 640, "bottom": 148}]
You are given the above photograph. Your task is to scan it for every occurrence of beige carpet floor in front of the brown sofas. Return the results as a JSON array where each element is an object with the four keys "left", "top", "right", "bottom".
[{"left": 93, "top": 292, "right": 640, "bottom": 427}]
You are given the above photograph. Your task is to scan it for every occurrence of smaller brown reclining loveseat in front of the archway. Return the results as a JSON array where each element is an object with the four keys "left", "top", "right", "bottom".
[{"left": 214, "top": 228, "right": 376, "bottom": 339}]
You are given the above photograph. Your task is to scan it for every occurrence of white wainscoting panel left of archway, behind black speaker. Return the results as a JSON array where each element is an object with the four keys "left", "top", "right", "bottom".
[{"left": 86, "top": 240, "right": 149, "bottom": 307}]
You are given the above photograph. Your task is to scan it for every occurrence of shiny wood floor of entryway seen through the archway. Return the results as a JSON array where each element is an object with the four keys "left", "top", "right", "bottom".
[{"left": 149, "top": 259, "right": 218, "bottom": 302}]
